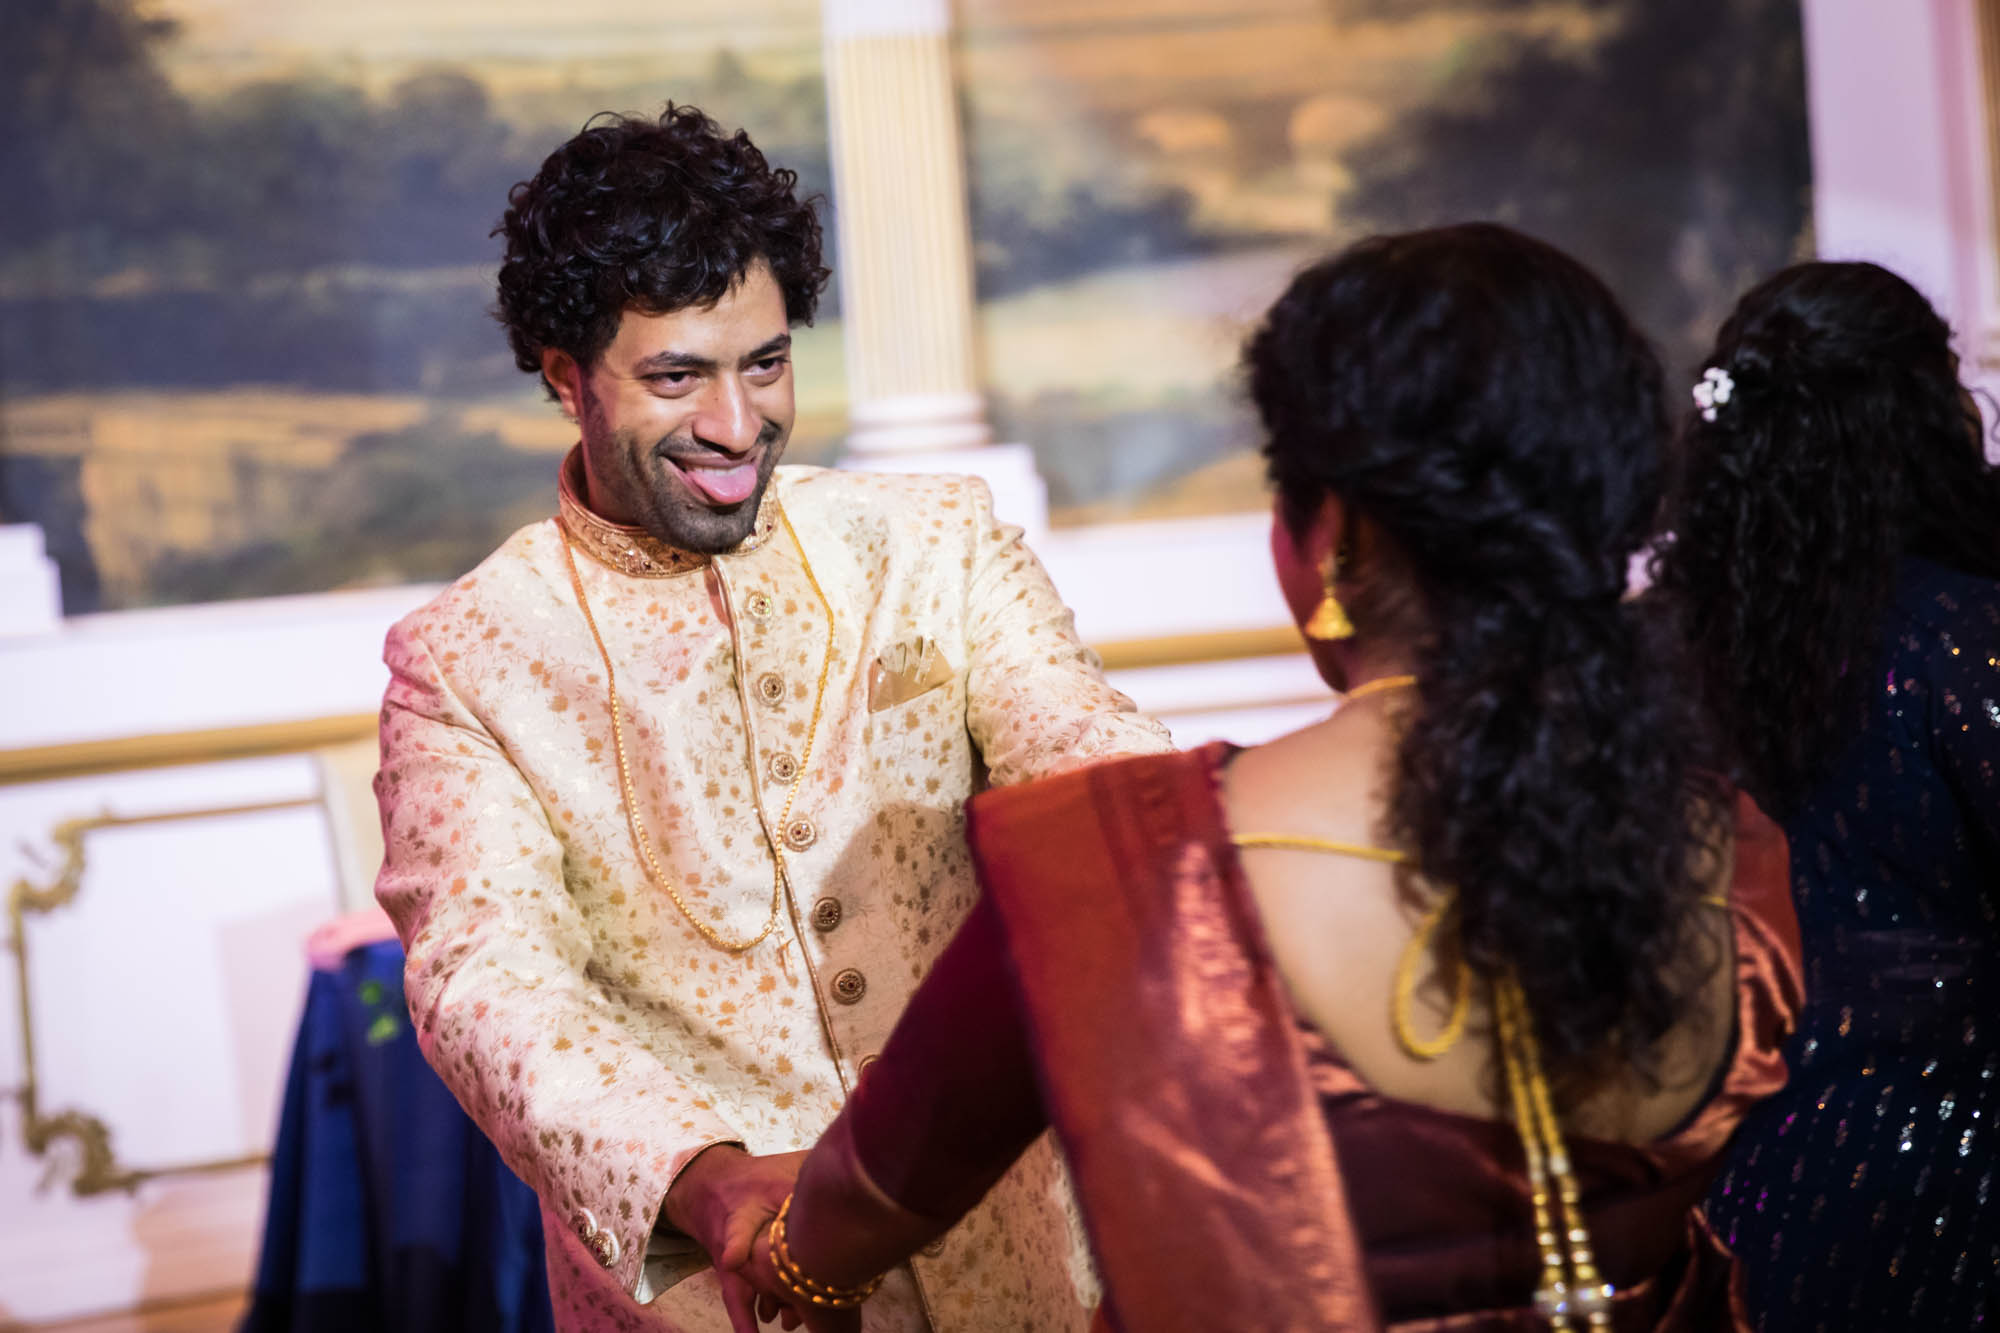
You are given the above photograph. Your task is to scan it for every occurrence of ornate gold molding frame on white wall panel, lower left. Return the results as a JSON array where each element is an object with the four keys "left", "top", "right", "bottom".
[{"left": 6, "top": 797, "right": 320, "bottom": 1197}]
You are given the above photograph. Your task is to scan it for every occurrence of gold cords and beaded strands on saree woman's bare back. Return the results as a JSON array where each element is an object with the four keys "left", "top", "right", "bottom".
[{"left": 1230, "top": 677, "right": 1614, "bottom": 1329}]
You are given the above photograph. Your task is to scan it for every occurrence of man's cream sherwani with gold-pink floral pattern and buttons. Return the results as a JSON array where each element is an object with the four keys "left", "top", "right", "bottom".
[{"left": 376, "top": 456, "right": 1168, "bottom": 1333}]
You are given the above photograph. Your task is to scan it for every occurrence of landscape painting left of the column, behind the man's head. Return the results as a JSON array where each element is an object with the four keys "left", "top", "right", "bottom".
[{"left": 0, "top": 0, "right": 844, "bottom": 614}]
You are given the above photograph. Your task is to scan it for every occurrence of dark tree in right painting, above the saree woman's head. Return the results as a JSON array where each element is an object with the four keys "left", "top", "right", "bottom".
[{"left": 1340, "top": 0, "right": 1812, "bottom": 366}]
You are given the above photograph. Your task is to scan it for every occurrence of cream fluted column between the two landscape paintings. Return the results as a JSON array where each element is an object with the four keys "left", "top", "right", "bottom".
[{"left": 820, "top": 0, "right": 1048, "bottom": 530}]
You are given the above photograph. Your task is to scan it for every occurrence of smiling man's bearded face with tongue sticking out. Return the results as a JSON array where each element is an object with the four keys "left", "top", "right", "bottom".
[{"left": 542, "top": 260, "right": 796, "bottom": 554}]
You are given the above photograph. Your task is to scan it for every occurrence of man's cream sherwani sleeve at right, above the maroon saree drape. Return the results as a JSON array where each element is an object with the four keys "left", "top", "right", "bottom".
[{"left": 966, "top": 482, "right": 1174, "bottom": 787}]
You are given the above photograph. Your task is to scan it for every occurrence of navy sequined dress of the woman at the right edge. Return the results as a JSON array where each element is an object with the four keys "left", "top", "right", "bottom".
[{"left": 1708, "top": 560, "right": 2000, "bottom": 1333}]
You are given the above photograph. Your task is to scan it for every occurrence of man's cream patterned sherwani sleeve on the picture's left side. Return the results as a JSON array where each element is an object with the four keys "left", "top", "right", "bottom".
[{"left": 376, "top": 628, "right": 742, "bottom": 1299}]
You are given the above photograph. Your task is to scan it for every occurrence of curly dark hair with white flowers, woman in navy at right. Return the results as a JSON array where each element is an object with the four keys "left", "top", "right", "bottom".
[{"left": 1654, "top": 262, "right": 2000, "bottom": 815}]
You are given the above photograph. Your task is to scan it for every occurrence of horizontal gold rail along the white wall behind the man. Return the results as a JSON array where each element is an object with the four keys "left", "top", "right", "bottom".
[{"left": 0, "top": 624, "right": 1304, "bottom": 787}]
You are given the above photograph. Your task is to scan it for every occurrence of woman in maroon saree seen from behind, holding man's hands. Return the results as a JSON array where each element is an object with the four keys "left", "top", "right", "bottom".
[{"left": 746, "top": 226, "right": 1800, "bottom": 1333}]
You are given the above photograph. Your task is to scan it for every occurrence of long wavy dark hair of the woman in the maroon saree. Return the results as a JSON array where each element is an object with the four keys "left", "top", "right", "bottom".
[{"left": 1246, "top": 224, "right": 1728, "bottom": 1101}]
